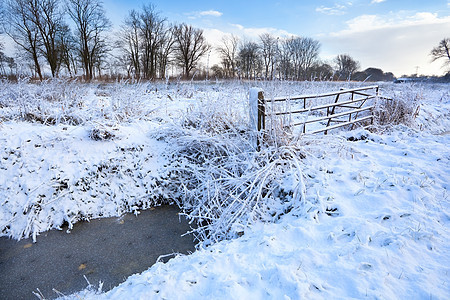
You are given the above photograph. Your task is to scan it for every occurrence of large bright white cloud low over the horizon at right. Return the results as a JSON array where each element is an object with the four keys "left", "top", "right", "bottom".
[{"left": 321, "top": 12, "right": 450, "bottom": 76}]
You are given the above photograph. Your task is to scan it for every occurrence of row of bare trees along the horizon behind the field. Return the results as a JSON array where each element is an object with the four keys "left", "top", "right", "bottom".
[{"left": 0, "top": 0, "right": 450, "bottom": 81}]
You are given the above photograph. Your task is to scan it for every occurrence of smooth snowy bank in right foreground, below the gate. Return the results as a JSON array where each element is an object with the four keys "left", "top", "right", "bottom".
[{"left": 61, "top": 127, "right": 450, "bottom": 299}]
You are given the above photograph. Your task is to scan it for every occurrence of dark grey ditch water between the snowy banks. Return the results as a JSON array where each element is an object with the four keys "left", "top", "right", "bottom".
[{"left": 0, "top": 206, "right": 195, "bottom": 300}]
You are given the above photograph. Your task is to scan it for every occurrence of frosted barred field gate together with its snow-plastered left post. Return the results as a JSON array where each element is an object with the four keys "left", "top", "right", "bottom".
[{"left": 250, "top": 85, "right": 385, "bottom": 144}]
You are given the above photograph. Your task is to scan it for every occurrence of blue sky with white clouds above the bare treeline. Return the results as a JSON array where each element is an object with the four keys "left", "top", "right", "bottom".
[{"left": 104, "top": 0, "right": 450, "bottom": 76}]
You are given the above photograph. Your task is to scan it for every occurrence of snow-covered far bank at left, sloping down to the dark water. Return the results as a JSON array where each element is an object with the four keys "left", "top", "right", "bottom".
[{"left": 0, "top": 123, "right": 168, "bottom": 240}]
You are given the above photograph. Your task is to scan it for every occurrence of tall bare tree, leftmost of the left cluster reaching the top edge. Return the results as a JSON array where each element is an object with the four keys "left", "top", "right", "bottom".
[{"left": 3, "top": 0, "right": 43, "bottom": 80}]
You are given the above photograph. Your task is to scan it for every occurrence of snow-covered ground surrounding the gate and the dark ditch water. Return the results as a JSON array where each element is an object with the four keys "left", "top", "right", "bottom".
[{"left": 0, "top": 82, "right": 450, "bottom": 299}]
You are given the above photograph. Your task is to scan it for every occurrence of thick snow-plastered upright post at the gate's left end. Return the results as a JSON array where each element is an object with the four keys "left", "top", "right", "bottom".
[{"left": 249, "top": 88, "right": 266, "bottom": 151}]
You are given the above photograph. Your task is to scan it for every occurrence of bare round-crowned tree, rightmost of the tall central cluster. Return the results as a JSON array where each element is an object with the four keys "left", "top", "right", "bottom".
[{"left": 174, "top": 23, "right": 211, "bottom": 78}]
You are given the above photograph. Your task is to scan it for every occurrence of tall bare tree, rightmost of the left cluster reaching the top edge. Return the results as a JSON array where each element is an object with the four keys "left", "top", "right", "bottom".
[{"left": 67, "top": 0, "right": 110, "bottom": 81}]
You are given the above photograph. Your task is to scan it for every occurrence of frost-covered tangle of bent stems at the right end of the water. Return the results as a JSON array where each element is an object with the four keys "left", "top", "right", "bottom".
[{"left": 160, "top": 119, "right": 304, "bottom": 245}]
